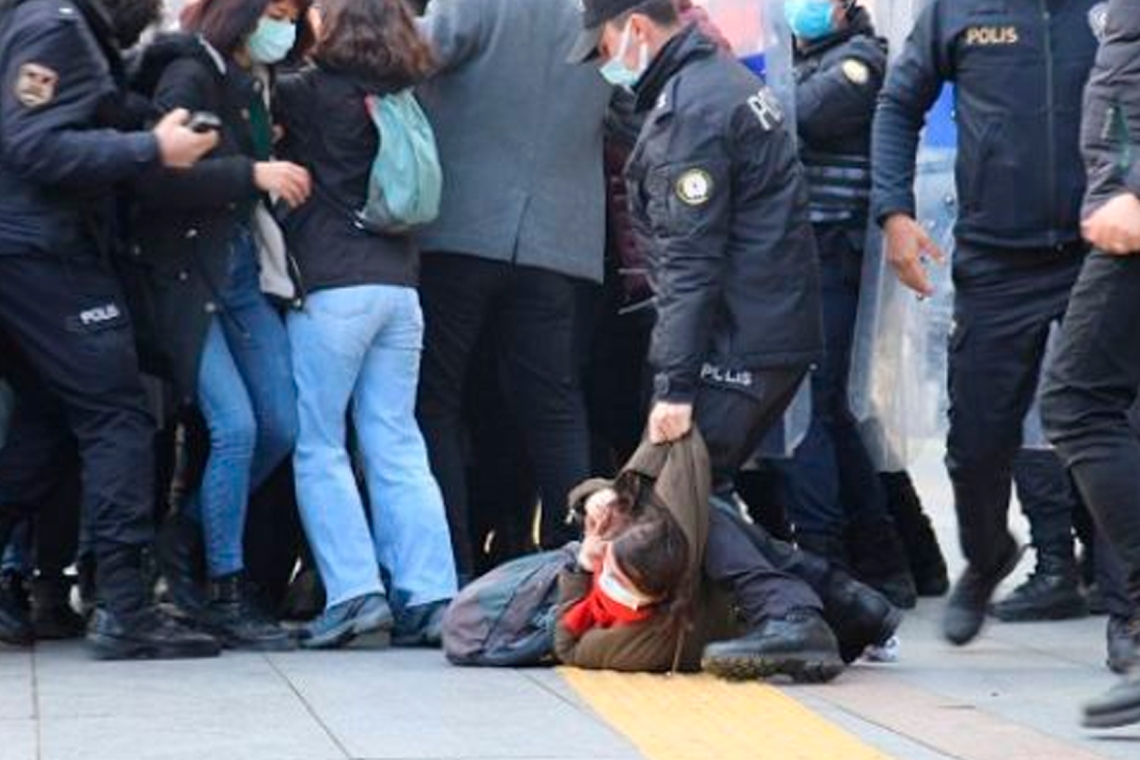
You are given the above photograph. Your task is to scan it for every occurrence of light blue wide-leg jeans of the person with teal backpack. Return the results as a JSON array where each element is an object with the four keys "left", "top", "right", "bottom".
[{"left": 288, "top": 285, "right": 456, "bottom": 608}]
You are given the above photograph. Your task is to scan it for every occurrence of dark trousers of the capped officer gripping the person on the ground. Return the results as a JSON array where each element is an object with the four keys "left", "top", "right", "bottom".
[{"left": 694, "top": 368, "right": 823, "bottom": 626}]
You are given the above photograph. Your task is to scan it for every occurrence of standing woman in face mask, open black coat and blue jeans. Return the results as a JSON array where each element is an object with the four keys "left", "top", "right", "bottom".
[{"left": 128, "top": 0, "right": 310, "bottom": 649}]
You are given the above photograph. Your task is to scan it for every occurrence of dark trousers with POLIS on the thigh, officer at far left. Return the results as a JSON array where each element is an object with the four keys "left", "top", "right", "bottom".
[{"left": 0, "top": 252, "right": 154, "bottom": 608}]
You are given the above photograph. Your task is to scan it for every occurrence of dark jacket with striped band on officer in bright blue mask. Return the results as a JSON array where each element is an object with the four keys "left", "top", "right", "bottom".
[{"left": 796, "top": 8, "right": 887, "bottom": 230}]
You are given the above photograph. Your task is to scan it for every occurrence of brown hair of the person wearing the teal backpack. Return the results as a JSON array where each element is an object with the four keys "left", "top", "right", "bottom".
[{"left": 312, "top": 0, "right": 434, "bottom": 87}]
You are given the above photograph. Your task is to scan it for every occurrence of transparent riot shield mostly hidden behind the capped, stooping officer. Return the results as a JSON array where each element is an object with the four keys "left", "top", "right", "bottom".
[{"left": 694, "top": 0, "right": 812, "bottom": 458}]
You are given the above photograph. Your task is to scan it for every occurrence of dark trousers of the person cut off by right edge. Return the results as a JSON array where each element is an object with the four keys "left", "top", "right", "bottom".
[{"left": 1042, "top": 252, "right": 1140, "bottom": 610}]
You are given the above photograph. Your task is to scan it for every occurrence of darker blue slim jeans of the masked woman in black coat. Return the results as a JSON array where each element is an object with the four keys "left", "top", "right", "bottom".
[{"left": 185, "top": 234, "right": 296, "bottom": 578}]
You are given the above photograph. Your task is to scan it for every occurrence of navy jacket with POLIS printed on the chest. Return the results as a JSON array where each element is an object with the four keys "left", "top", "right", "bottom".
[{"left": 872, "top": 0, "right": 1100, "bottom": 248}]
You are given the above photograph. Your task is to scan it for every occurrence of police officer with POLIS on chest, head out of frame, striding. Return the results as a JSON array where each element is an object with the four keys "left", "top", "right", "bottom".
[{"left": 871, "top": 0, "right": 1097, "bottom": 645}]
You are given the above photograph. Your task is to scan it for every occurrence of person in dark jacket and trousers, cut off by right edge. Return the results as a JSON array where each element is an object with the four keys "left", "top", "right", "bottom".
[{"left": 1041, "top": 0, "right": 1140, "bottom": 728}]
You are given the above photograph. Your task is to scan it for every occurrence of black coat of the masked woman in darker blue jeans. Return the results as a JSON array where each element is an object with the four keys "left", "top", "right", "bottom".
[{"left": 120, "top": 35, "right": 260, "bottom": 403}]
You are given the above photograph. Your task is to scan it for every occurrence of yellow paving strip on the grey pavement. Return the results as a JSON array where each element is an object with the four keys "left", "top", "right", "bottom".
[{"left": 560, "top": 668, "right": 891, "bottom": 760}]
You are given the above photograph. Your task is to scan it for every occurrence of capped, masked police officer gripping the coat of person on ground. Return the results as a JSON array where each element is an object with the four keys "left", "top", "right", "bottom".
[{"left": 571, "top": 0, "right": 857, "bottom": 679}]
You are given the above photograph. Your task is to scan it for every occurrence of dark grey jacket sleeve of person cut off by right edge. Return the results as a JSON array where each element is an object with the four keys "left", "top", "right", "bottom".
[{"left": 1081, "top": 0, "right": 1140, "bottom": 214}]
